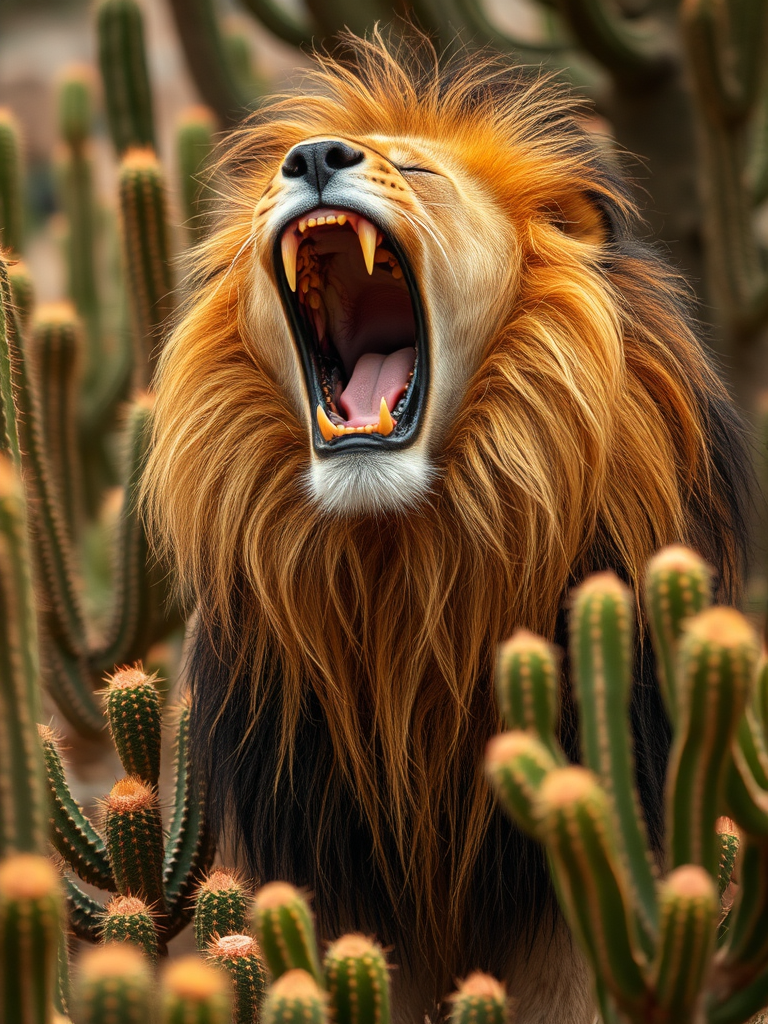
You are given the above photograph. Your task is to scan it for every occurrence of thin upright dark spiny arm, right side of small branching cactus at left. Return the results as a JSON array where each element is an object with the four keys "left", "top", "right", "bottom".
[{"left": 163, "top": 703, "right": 214, "bottom": 937}]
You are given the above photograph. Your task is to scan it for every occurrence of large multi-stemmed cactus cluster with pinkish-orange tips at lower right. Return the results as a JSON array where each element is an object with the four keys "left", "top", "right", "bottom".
[{"left": 487, "top": 549, "right": 768, "bottom": 1024}]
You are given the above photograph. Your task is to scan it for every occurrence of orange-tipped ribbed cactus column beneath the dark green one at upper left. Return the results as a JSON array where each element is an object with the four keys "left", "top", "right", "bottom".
[{"left": 119, "top": 148, "right": 173, "bottom": 387}]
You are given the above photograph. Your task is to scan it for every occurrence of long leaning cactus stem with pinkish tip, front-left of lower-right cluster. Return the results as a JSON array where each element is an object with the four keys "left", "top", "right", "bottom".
[{"left": 538, "top": 767, "right": 648, "bottom": 1017}]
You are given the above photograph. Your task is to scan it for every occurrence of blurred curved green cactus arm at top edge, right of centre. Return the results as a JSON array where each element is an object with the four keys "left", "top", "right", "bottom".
[{"left": 558, "top": 0, "right": 675, "bottom": 88}]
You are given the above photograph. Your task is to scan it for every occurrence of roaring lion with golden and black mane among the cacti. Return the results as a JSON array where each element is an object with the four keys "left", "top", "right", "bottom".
[{"left": 144, "top": 33, "right": 745, "bottom": 1024}]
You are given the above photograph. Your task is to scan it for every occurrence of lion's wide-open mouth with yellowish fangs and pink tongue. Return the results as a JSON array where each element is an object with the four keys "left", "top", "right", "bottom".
[{"left": 275, "top": 207, "right": 427, "bottom": 454}]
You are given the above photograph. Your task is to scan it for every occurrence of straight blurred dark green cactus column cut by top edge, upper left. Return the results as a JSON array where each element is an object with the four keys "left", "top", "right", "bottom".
[{"left": 96, "top": 0, "right": 155, "bottom": 156}]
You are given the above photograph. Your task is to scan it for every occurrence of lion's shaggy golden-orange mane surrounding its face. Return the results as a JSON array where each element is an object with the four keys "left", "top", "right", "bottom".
[{"left": 145, "top": 29, "right": 738, "bottom": 983}]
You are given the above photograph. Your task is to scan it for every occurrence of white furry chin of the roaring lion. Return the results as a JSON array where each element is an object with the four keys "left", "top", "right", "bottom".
[{"left": 307, "top": 449, "right": 435, "bottom": 517}]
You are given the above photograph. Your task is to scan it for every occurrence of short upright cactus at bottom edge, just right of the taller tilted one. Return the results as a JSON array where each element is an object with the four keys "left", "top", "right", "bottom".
[{"left": 323, "top": 935, "right": 389, "bottom": 1024}]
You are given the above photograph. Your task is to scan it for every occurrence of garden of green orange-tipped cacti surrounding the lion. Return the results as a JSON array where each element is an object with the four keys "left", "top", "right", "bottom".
[{"left": 0, "top": 0, "right": 768, "bottom": 1024}]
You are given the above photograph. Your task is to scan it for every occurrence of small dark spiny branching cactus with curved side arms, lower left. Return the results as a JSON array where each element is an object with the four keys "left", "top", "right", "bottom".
[{"left": 36, "top": 667, "right": 213, "bottom": 956}]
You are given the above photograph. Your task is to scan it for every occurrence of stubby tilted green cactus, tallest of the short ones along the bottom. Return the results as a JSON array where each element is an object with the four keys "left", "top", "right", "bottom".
[{"left": 253, "top": 882, "right": 323, "bottom": 982}]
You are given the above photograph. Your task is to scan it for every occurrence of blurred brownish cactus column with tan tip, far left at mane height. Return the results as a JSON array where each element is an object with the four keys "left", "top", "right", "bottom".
[{"left": 30, "top": 302, "right": 85, "bottom": 538}]
